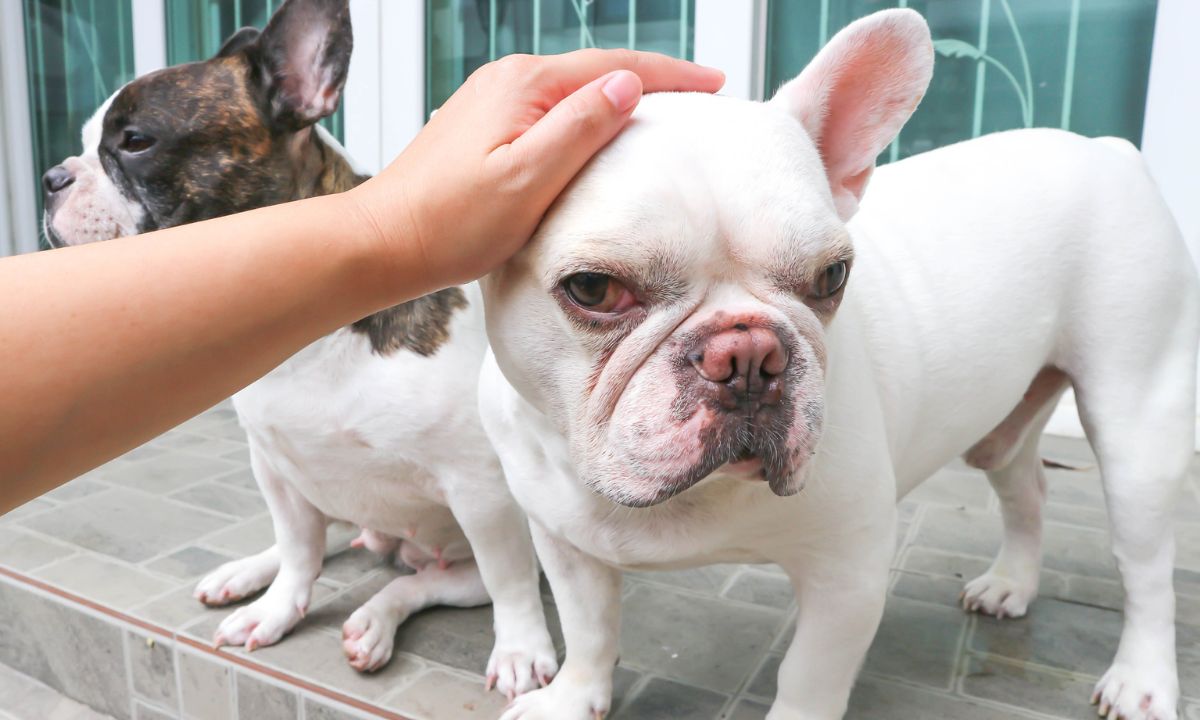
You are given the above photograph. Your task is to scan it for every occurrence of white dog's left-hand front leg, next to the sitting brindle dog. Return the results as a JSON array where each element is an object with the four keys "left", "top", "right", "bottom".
[{"left": 500, "top": 522, "right": 620, "bottom": 720}]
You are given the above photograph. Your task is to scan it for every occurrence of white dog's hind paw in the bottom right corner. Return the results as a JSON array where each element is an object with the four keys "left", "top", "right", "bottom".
[{"left": 1092, "top": 659, "right": 1180, "bottom": 720}]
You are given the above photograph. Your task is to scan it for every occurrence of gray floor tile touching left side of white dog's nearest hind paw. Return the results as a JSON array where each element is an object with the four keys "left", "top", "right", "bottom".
[{"left": 962, "top": 656, "right": 1096, "bottom": 720}]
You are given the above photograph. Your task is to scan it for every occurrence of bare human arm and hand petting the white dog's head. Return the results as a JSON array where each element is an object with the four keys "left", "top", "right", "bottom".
[{"left": 0, "top": 50, "right": 722, "bottom": 511}]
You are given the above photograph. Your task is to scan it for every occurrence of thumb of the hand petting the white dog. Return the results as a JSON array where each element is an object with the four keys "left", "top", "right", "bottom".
[{"left": 510, "top": 70, "right": 642, "bottom": 203}]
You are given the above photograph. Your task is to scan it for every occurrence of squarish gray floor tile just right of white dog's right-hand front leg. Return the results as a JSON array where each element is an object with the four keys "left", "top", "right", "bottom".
[{"left": 863, "top": 598, "right": 967, "bottom": 689}]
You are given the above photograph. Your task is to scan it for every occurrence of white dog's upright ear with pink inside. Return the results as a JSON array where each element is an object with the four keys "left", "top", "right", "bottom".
[{"left": 770, "top": 10, "right": 934, "bottom": 221}]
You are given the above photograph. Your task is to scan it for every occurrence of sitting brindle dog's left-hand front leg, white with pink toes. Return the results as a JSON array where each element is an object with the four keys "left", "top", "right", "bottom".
[{"left": 212, "top": 442, "right": 328, "bottom": 650}]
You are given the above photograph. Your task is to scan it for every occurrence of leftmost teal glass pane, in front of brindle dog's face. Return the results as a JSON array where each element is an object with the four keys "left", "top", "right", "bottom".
[{"left": 24, "top": 0, "right": 133, "bottom": 247}]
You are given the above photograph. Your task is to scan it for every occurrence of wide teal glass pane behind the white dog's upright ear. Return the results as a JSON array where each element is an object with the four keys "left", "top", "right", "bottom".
[{"left": 767, "top": 0, "right": 1157, "bottom": 161}]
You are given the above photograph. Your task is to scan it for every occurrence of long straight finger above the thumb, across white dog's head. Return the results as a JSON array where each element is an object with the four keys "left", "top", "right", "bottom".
[{"left": 545, "top": 48, "right": 725, "bottom": 97}]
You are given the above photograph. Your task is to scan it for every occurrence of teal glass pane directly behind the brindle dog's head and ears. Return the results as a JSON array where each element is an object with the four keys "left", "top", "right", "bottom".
[{"left": 164, "top": 0, "right": 344, "bottom": 142}]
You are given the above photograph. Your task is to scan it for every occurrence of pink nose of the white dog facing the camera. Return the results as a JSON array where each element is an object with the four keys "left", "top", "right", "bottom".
[{"left": 688, "top": 323, "right": 790, "bottom": 410}]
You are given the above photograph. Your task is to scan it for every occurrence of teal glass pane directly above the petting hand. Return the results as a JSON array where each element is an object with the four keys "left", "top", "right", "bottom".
[{"left": 425, "top": 0, "right": 695, "bottom": 114}]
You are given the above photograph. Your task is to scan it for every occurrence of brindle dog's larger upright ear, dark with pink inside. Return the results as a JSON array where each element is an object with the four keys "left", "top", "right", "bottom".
[{"left": 247, "top": 0, "right": 354, "bottom": 132}]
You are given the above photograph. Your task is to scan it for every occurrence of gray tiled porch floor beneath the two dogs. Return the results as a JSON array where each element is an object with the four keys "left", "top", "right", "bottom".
[{"left": 0, "top": 404, "right": 1200, "bottom": 720}]
